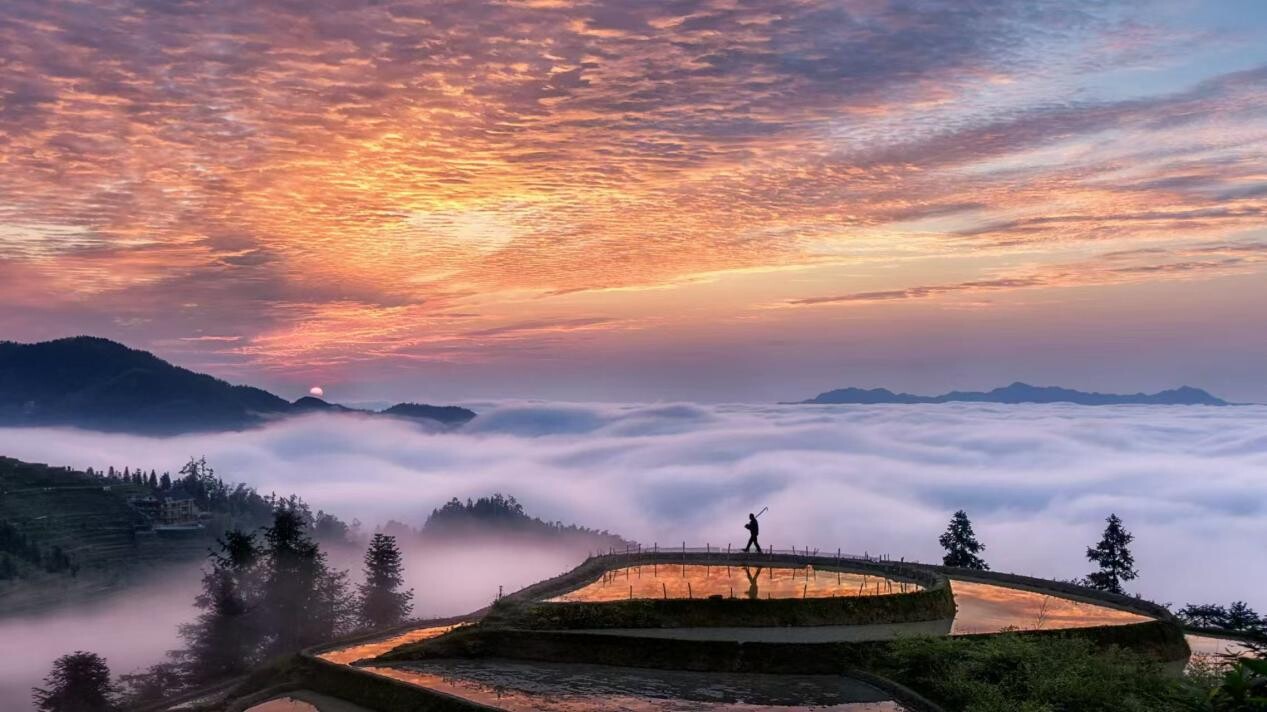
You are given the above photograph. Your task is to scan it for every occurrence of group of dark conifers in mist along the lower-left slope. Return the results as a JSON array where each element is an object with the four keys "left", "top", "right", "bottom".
[{"left": 33, "top": 499, "right": 413, "bottom": 712}]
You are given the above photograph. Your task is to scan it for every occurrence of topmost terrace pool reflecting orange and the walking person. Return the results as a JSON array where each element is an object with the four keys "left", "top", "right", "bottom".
[{"left": 550, "top": 564, "right": 920, "bottom": 603}]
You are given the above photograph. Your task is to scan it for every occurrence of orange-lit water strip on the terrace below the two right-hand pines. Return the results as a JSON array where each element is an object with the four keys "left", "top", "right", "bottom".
[{"left": 950, "top": 579, "right": 1152, "bottom": 635}]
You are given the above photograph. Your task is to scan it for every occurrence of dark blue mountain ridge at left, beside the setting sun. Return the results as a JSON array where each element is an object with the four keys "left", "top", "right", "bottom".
[{"left": 0, "top": 336, "right": 475, "bottom": 435}]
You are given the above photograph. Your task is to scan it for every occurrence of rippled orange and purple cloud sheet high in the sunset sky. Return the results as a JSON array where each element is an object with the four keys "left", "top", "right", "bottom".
[{"left": 0, "top": 0, "right": 1264, "bottom": 378}]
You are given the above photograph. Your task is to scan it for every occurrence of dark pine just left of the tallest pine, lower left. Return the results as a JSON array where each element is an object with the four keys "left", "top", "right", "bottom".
[{"left": 179, "top": 530, "right": 260, "bottom": 683}]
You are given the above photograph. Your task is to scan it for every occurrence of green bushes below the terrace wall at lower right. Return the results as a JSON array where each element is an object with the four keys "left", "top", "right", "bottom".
[{"left": 884, "top": 633, "right": 1188, "bottom": 712}]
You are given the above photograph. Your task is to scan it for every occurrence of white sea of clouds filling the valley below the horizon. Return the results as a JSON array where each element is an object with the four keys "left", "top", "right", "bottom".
[{"left": 0, "top": 403, "right": 1267, "bottom": 608}]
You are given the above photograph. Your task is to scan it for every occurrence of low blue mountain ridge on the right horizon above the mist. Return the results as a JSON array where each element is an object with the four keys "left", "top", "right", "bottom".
[{"left": 798, "top": 381, "right": 1229, "bottom": 405}]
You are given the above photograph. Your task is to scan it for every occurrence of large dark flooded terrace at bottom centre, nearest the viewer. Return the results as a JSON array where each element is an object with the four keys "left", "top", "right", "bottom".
[{"left": 374, "top": 659, "right": 903, "bottom": 712}]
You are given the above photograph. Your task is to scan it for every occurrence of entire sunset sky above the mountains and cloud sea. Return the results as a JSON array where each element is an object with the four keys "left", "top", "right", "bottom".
[{"left": 0, "top": 0, "right": 1267, "bottom": 402}]
